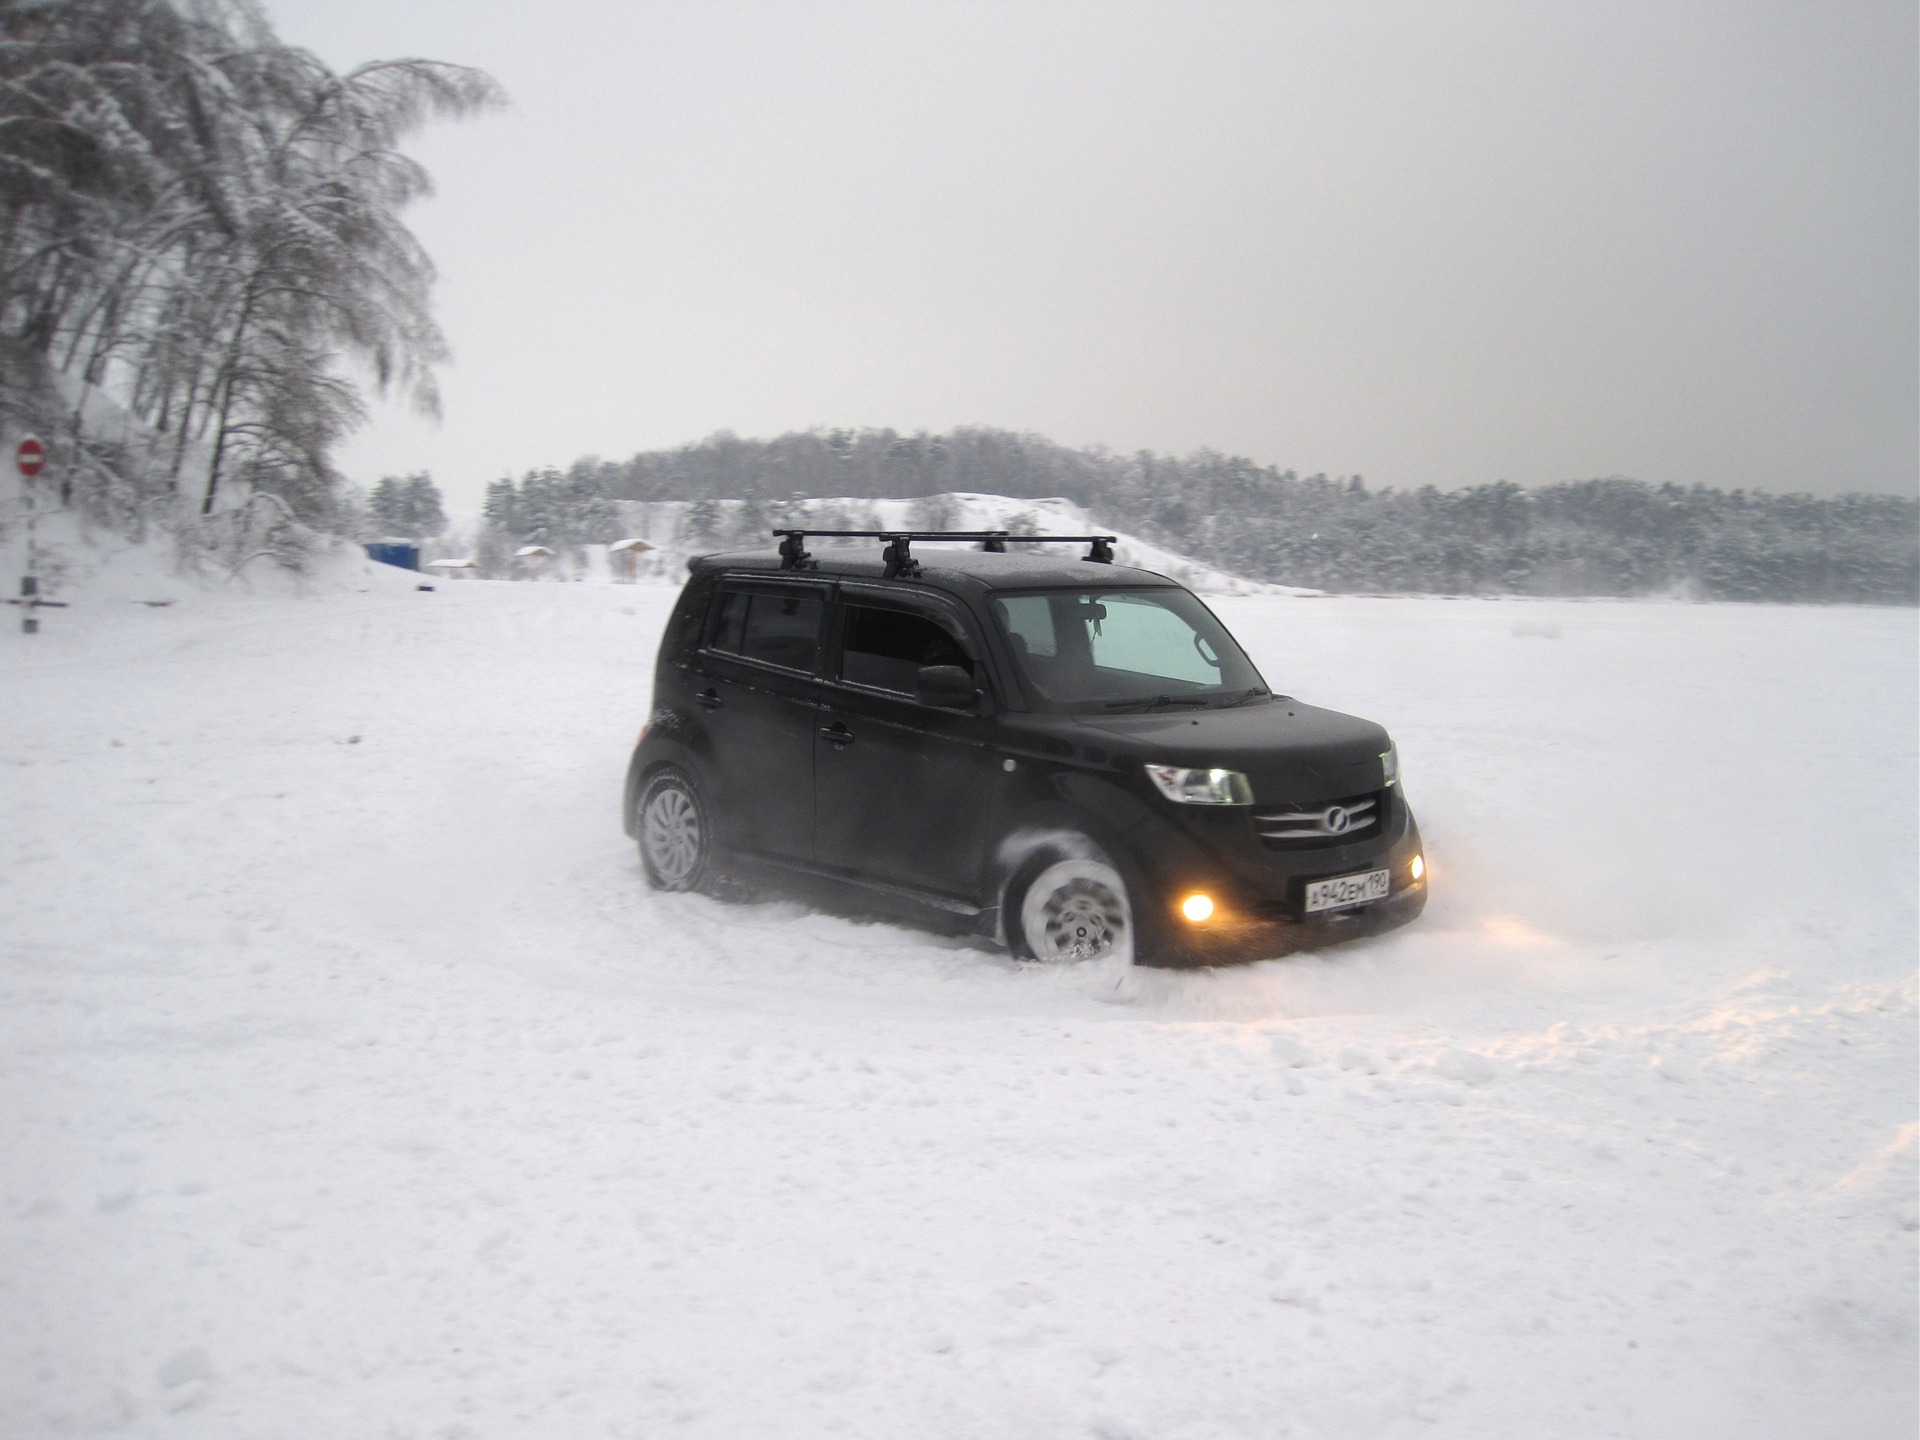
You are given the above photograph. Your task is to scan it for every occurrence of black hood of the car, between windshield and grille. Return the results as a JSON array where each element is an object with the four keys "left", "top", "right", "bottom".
[{"left": 1075, "top": 697, "right": 1390, "bottom": 804}]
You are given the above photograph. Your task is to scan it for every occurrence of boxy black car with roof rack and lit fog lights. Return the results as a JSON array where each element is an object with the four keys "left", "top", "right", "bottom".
[{"left": 624, "top": 532, "right": 1427, "bottom": 964}]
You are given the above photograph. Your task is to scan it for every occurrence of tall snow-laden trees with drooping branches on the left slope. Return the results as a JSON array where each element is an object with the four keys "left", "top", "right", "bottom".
[{"left": 0, "top": 0, "right": 501, "bottom": 541}]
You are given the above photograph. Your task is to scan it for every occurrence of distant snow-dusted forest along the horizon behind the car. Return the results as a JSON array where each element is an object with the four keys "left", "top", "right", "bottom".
[{"left": 486, "top": 428, "right": 1920, "bottom": 605}]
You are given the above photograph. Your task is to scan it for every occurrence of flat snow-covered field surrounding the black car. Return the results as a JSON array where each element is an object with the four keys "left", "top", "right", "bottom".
[{"left": 0, "top": 572, "right": 1920, "bottom": 1440}]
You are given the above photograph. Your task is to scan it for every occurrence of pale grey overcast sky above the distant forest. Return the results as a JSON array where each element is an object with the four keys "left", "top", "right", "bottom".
[{"left": 267, "top": 0, "right": 1920, "bottom": 503}]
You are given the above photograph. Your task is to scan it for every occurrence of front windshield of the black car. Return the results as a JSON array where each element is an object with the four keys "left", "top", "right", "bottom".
[{"left": 993, "top": 588, "right": 1267, "bottom": 712}]
